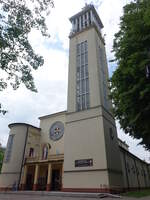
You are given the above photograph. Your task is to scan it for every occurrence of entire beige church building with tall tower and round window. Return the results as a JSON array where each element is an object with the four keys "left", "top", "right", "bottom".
[{"left": 0, "top": 5, "right": 150, "bottom": 192}]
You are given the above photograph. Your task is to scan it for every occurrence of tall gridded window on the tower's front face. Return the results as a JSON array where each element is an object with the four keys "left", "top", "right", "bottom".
[{"left": 76, "top": 41, "right": 90, "bottom": 111}]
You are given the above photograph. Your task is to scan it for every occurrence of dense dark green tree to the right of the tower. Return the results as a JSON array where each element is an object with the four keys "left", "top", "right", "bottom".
[{"left": 110, "top": 0, "right": 150, "bottom": 150}]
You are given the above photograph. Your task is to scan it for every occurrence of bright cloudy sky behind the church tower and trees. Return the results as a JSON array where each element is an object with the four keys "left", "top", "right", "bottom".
[{"left": 0, "top": 0, "right": 150, "bottom": 162}]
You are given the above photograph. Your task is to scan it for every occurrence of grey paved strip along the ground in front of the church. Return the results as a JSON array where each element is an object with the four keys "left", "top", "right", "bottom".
[{"left": 0, "top": 192, "right": 150, "bottom": 200}]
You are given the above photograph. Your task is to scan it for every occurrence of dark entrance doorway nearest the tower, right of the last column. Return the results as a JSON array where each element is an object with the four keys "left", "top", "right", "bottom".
[{"left": 51, "top": 169, "right": 61, "bottom": 191}]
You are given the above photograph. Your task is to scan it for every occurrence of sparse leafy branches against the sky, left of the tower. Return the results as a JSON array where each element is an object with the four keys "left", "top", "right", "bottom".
[{"left": 0, "top": 0, "right": 54, "bottom": 114}]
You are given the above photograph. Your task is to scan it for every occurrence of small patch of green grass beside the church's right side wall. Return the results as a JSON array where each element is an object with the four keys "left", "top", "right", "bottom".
[{"left": 123, "top": 189, "right": 150, "bottom": 198}]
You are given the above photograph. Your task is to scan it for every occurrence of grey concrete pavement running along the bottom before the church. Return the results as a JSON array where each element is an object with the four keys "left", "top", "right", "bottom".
[{"left": 0, "top": 191, "right": 150, "bottom": 200}]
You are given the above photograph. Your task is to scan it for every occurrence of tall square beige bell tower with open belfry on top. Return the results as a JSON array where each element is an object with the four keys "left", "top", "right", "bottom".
[{"left": 63, "top": 5, "right": 122, "bottom": 192}]
